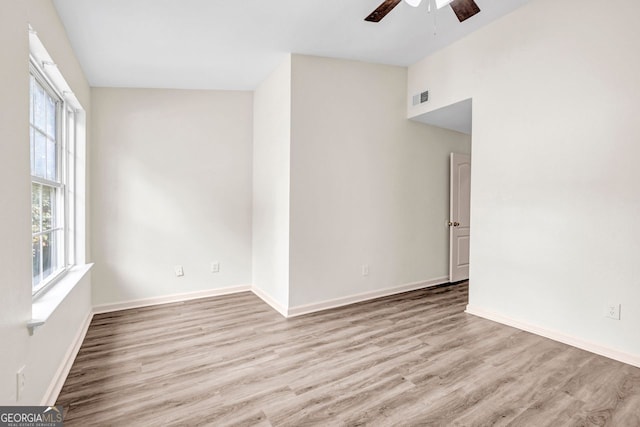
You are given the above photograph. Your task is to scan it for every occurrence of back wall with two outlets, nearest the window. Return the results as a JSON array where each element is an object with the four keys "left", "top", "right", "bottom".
[{"left": 91, "top": 88, "right": 252, "bottom": 305}]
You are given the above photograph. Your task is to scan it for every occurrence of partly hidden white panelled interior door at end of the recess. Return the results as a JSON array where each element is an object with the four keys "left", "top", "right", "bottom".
[{"left": 449, "top": 153, "right": 471, "bottom": 282}]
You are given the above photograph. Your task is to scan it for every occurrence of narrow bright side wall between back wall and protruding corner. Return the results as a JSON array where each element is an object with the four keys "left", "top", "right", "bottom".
[{"left": 253, "top": 55, "right": 291, "bottom": 310}]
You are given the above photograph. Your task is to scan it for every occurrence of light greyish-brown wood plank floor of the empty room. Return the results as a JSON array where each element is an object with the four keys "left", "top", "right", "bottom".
[{"left": 58, "top": 283, "right": 640, "bottom": 427}]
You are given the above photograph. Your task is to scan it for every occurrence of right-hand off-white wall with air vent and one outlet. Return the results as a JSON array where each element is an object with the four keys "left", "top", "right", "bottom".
[{"left": 408, "top": 0, "right": 640, "bottom": 360}]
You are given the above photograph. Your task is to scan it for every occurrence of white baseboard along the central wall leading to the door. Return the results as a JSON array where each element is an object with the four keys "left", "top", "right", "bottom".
[{"left": 287, "top": 276, "right": 449, "bottom": 317}]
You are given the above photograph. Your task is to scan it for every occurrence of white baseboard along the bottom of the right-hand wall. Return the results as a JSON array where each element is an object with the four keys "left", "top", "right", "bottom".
[{"left": 465, "top": 305, "right": 640, "bottom": 368}]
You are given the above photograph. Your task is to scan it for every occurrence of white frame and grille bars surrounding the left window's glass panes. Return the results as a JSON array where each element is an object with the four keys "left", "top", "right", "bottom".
[{"left": 29, "top": 56, "right": 76, "bottom": 297}]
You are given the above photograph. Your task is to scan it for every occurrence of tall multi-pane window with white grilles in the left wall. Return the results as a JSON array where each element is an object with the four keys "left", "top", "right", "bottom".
[{"left": 29, "top": 62, "right": 74, "bottom": 294}]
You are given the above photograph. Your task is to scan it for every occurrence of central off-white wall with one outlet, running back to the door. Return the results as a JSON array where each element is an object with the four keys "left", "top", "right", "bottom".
[{"left": 289, "top": 55, "right": 470, "bottom": 307}]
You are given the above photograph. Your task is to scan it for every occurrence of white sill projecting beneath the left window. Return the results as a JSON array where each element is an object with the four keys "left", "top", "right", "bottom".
[{"left": 27, "top": 264, "right": 93, "bottom": 335}]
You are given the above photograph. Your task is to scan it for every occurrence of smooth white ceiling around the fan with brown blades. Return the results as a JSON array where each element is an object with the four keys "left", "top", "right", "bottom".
[{"left": 51, "top": 0, "right": 528, "bottom": 90}]
